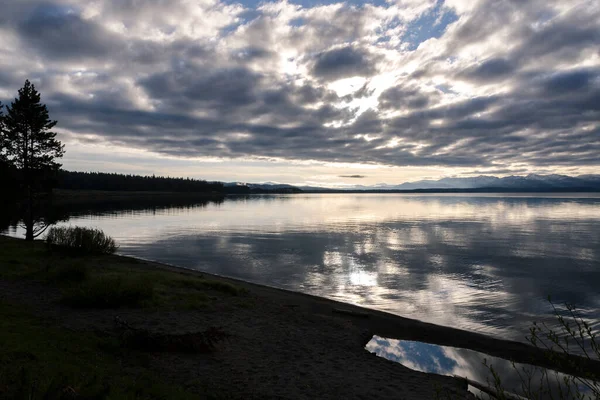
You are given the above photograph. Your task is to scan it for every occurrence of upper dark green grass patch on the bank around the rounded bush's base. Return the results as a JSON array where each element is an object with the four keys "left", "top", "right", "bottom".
[{"left": 0, "top": 236, "right": 247, "bottom": 310}]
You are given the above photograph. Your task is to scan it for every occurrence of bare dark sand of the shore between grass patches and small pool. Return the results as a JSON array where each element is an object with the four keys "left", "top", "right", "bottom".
[{"left": 0, "top": 242, "right": 596, "bottom": 399}]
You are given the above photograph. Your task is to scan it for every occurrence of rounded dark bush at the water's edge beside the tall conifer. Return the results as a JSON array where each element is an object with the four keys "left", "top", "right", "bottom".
[{"left": 46, "top": 226, "right": 118, "bottom": 254}]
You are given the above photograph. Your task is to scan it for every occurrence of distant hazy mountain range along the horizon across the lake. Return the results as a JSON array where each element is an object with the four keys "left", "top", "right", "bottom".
[{"left": 225, "top": 174, "right": 600, "bottom": 192}]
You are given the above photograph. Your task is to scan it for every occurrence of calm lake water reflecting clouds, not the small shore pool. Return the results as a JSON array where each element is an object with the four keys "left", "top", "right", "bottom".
[{"left": 5, "top": 194, "right": 600, "bottom": 340}]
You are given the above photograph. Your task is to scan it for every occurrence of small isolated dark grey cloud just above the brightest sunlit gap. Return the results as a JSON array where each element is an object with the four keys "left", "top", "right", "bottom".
[{"left": 312, "top": 46, "right": 375, "bottom": 80}]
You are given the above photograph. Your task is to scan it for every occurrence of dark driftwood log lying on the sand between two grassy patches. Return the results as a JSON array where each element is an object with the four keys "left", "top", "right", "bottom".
[{"left": 115, "top": 317, "right": 231, "bottom": 353}]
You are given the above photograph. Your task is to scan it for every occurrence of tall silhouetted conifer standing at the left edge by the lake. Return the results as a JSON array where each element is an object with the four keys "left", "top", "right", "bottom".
[{"left": 0, "top": 80, "right": 64, "bottom": 240}]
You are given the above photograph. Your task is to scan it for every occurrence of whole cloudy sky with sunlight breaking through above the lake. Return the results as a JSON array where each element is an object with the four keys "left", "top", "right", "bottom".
[{"left": 0, "top": 0, "right": 600, "bottom": 187}]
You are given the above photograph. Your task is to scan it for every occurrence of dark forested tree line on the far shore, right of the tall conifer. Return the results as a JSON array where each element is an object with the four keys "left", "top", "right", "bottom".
[{"left": 56, "top": 170, "right": 224, "bottom": 193}]
